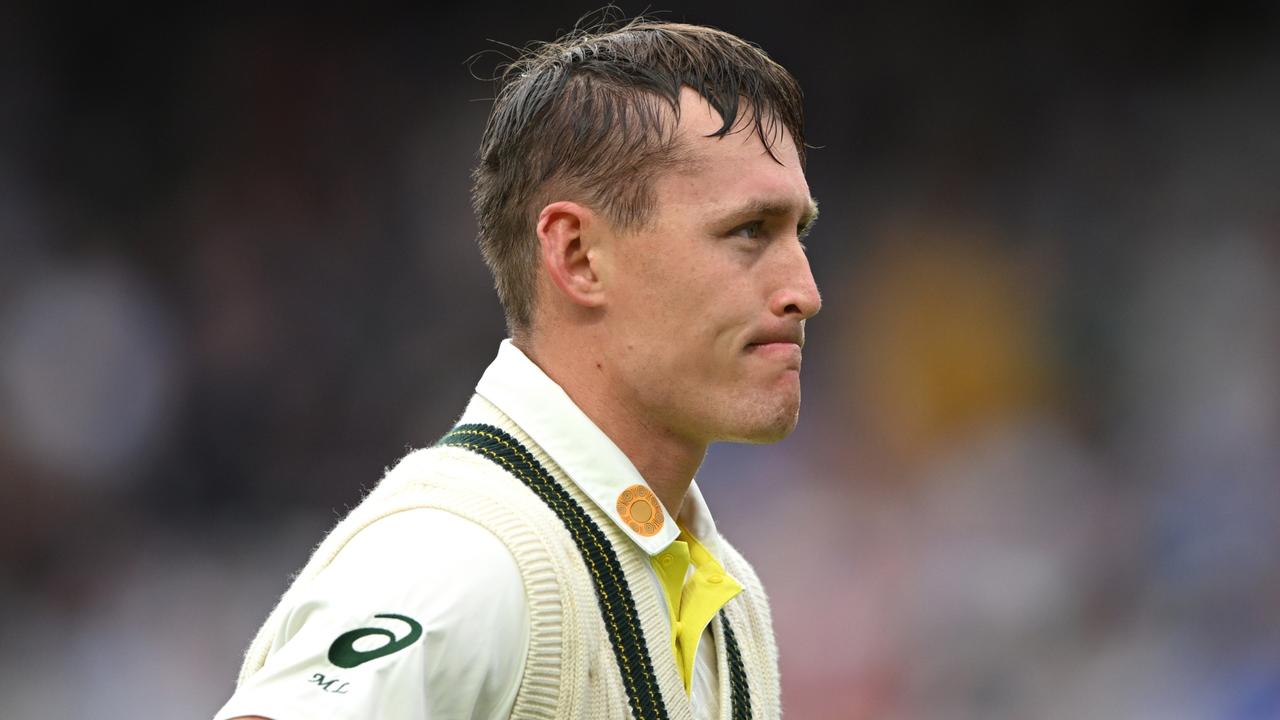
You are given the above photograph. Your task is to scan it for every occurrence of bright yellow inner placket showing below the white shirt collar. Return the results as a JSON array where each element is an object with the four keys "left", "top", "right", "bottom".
[{"left": 649, "top": 528, "right": 742, "bottom": 694}]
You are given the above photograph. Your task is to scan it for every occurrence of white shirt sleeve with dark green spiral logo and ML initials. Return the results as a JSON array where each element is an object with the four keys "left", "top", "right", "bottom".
[{"left": 216, "top": 509, "right": 529, "bottom": 720}]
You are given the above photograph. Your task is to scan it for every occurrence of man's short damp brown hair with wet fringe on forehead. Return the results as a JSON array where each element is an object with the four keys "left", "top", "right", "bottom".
[{"left": 472, "top": 18, "right": 805, "bottom": 333}]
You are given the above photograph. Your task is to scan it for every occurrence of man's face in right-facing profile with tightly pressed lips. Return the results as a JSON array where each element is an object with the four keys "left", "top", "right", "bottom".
[{"left": 602, "top": 88, "right": 822, "bottom": 443}]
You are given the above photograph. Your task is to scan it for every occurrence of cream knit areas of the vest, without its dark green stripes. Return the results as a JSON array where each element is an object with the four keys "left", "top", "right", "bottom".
[{"left": 241, "top": 398, "right": 781, "bottom": 720}]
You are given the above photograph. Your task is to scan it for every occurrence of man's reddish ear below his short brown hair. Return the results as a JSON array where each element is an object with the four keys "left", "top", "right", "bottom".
[{"left": 538, "top": 201, "right": 604, "bottom": 307}]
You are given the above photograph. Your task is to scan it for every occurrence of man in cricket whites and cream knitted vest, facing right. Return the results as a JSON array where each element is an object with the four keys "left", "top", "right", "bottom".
[{"left": 218, "top": 22, "right": 820, "bottom": 720}]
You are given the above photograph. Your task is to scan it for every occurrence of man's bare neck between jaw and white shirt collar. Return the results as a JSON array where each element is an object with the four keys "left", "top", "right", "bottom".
[{"left": 513, "top": 327, "right": 707, "bottom": 512}]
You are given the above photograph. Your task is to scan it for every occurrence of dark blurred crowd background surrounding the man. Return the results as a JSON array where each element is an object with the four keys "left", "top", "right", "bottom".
[{"left": 0, "top": 0, "right": 1280, "bottom": 720}]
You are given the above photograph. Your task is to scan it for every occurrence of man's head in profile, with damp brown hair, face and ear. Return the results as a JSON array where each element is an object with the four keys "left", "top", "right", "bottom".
[{"left": 474, "top": 22, "right": 820, "bottom": 442}]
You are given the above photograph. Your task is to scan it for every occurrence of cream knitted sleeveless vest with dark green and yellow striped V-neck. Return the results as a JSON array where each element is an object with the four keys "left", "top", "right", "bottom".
[{"left": 239, "top": 400, "right": 781, "bottom": 720}]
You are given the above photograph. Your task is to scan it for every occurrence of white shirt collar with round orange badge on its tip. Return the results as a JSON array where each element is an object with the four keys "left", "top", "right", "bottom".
[{"left": 476, "top": 340, "right": 719, "bottom": 556}]
